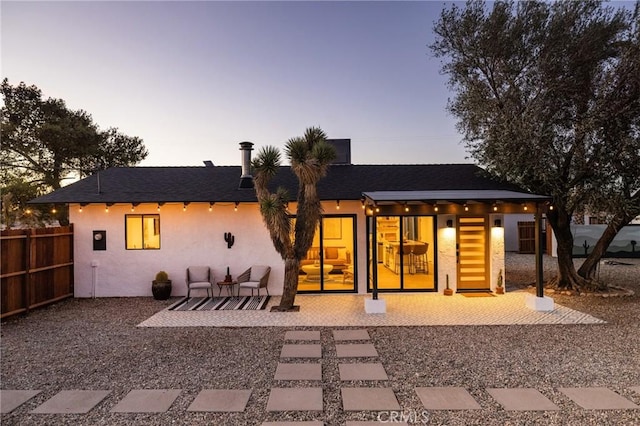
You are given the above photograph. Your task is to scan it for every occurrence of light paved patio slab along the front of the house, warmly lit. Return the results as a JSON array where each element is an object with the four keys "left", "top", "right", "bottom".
[{"left": 138, "top": 292, "right": 605, "bottom": 327}]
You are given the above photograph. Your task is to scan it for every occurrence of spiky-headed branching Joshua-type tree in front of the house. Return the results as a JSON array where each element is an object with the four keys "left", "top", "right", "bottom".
[{"left": 252, "top": 127, "right": 336, "bottom": 311}]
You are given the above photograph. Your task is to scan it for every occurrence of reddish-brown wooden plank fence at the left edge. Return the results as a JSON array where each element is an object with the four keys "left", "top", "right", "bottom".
[{"left": 0, "top": 225, "right": 73, "bottom": 318}]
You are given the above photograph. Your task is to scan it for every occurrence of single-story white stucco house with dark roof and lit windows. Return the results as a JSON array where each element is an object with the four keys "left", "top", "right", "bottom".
[{"left": 31, "top": 139, "right": 550, "bottom": 304}]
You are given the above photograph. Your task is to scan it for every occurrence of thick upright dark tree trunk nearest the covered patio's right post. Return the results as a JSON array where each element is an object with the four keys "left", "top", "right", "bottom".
[{"left": 547, "top": 207, "right": 587, "bottom": 291}]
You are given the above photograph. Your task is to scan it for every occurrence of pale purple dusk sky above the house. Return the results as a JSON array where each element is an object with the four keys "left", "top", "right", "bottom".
[{"left": 0, "top": 1, "right": 472, "bottom": 166}]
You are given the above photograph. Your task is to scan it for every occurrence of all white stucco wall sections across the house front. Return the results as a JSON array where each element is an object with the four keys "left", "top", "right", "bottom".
[{"left": 69, "top": 201, "right": 505, "bottom": 297}]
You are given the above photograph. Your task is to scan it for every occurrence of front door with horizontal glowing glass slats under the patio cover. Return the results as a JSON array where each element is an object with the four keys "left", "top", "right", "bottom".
[{"left": 456, "top": 217, "right": 490, "bottom": 291}]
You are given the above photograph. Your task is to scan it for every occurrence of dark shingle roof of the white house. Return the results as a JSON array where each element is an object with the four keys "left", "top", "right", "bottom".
[{"left": 31, "top": 164, "right": 526, "bottom": 204}]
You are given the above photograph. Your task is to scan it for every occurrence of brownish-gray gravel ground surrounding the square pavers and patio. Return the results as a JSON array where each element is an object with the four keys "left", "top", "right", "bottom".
[{"left": 0, "top": 254, "right": 640, "bottom": 426}]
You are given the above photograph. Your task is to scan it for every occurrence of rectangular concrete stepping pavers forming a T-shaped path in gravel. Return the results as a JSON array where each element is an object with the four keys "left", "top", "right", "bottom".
[{"left": 0, "top": 329, "right": 640, "bottom": 426}]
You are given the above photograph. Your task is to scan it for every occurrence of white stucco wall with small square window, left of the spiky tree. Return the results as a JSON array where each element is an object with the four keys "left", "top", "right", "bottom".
[{"left": 70, "top": 203, "right": 283, "bottom": 297}]
